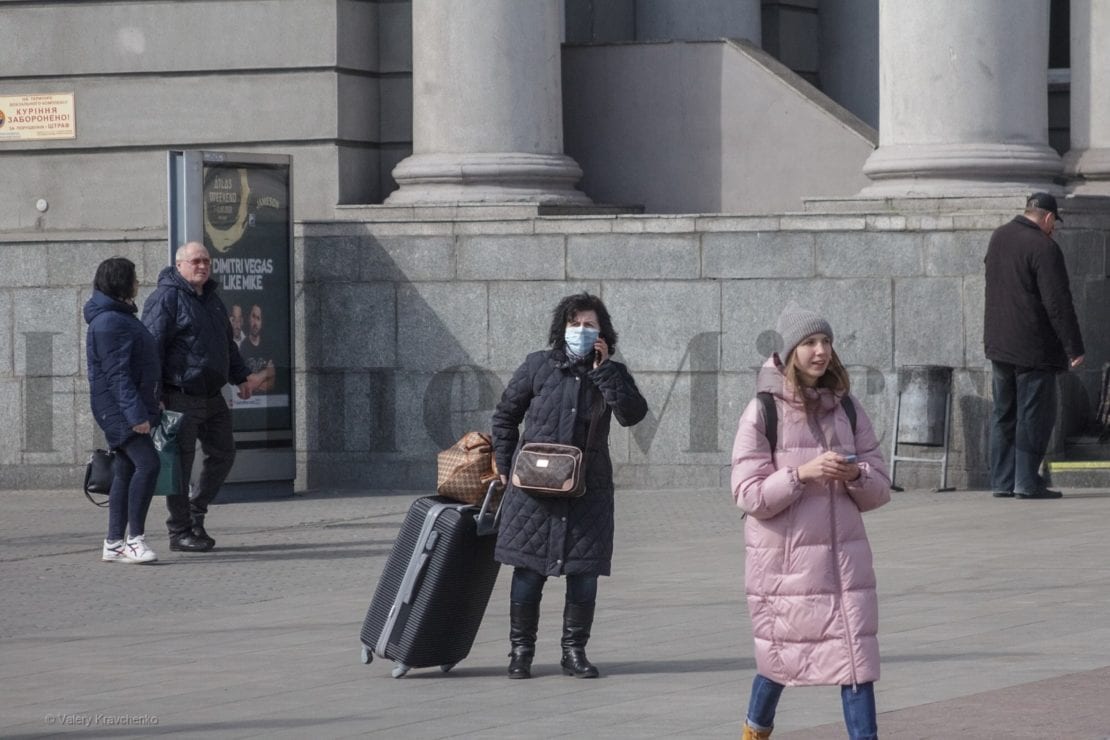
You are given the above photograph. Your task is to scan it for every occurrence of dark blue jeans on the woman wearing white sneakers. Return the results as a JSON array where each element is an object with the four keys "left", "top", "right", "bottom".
[{"left": 108, "top": 434, "right": 162, "bottom": 543}]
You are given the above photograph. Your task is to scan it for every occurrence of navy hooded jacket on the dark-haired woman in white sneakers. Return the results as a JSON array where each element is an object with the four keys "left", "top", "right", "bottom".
[{"left": 84, "top": 291, "right": 162, "bottom": 448}]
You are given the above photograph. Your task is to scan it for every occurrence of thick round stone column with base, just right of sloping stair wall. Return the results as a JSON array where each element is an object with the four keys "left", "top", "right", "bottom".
[{"left": 860, "top": 0, "right": 1063, "bottom": 197}]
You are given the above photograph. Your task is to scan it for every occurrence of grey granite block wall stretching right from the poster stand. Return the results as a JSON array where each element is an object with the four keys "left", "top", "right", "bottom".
[{"left": 288, "top": 204, "right": 1108, "bottom": 488}]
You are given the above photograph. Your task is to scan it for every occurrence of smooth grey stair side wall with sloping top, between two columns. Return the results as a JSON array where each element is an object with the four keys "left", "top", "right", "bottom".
[{"left": 563, "top": 40, "right": 877, "bottom": 214}]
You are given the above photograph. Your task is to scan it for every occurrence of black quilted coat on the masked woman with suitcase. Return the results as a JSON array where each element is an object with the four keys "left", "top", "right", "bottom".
[{"left": 493, "top": 349, "right": 647, "bottom": 576}]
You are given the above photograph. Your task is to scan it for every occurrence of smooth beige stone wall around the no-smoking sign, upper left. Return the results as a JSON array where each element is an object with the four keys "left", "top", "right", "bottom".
[{"left": 0, "top": 0, "right": 412, "bottom": 232}]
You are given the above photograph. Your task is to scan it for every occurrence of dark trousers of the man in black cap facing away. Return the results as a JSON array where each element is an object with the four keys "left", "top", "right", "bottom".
[{"left": 990, "top": 362, "right": 1056, "bottom": 494}]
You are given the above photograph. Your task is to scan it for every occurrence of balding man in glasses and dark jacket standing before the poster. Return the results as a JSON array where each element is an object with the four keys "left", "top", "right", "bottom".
[{"left": 142, "top": 242, "right": 259, "bottom": 553}]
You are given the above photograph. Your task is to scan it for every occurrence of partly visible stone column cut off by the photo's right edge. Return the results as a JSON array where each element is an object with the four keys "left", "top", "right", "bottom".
[{"left": 1063, "top": 0, "right": 1110, "bottom": 195}]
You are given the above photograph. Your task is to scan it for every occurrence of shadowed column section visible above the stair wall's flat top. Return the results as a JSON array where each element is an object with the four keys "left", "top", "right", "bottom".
[{"left": 636, "top": 0, "right": 763, "bottom": 47}]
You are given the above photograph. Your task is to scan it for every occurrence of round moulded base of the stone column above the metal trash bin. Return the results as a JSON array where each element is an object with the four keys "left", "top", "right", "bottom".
[{"left": 859, "top": 144, "right": 1063, "bottom": 197}]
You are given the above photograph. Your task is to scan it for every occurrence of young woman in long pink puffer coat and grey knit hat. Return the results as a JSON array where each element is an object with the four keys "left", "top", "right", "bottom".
[{"left": 731, "top": 304, "right": 890, "bottom": 740}]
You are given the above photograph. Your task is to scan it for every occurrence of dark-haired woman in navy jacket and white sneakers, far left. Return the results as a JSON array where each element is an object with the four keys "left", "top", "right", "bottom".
[{"left": 84, "top": 257, "right": 162, "bottom": 562}]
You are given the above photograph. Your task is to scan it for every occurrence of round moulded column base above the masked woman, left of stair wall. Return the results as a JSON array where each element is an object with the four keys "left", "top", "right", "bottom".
[{"left": 385, "top": 152, "right": 592, "bottom": 205}]
